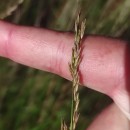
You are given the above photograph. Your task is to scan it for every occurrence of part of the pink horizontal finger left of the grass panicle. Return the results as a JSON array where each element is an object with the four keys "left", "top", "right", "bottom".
[{"left": 0, "top": 21, "right": 73, "bottom": 79}]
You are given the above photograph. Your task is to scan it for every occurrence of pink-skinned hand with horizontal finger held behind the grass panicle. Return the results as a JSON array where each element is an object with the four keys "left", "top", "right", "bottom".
[{"left": 0, "top": 21, "right": 130, "bottom": 130}]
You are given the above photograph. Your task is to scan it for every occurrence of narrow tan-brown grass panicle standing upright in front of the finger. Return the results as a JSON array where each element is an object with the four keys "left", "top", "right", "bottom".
[{"left": 61, "top": 13, "right": 86, "bottom": 130}]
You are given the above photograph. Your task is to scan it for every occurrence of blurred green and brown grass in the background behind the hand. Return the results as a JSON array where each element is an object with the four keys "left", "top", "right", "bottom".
[{"left": 0, "top": 0, "right": 130, "bottom": 130}]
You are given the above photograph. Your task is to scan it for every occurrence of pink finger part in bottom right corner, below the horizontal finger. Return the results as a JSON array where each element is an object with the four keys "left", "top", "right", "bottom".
[{"left": 87, "top": 104, "right": 130, "bottom": 130}]
